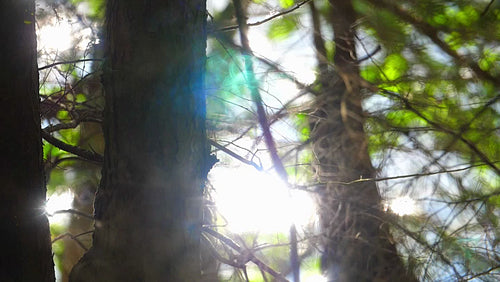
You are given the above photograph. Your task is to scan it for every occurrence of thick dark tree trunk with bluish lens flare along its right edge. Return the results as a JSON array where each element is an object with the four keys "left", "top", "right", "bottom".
[{"left": 70, "top": 0, "right": 210, "bottom": 281}]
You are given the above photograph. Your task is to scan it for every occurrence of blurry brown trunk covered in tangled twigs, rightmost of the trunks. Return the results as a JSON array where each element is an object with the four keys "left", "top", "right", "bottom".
[{"left": 311, "top": 0, "right": 416, "bottom": 282}]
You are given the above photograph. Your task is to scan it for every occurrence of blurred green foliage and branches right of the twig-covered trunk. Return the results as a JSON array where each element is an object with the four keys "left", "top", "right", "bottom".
[{"left": 355, "top": 0, "right": 500, "bottom": 280}]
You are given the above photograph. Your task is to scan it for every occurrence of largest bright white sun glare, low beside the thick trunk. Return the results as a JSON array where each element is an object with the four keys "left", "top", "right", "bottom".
[{"left": 211, "top": 167, "right": 315, "bottom": 233}]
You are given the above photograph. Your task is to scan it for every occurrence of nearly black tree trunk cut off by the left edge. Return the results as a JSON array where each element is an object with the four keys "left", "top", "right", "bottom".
[{"left": 0, "top": 0, "right": 54, "bottom": 281}]
